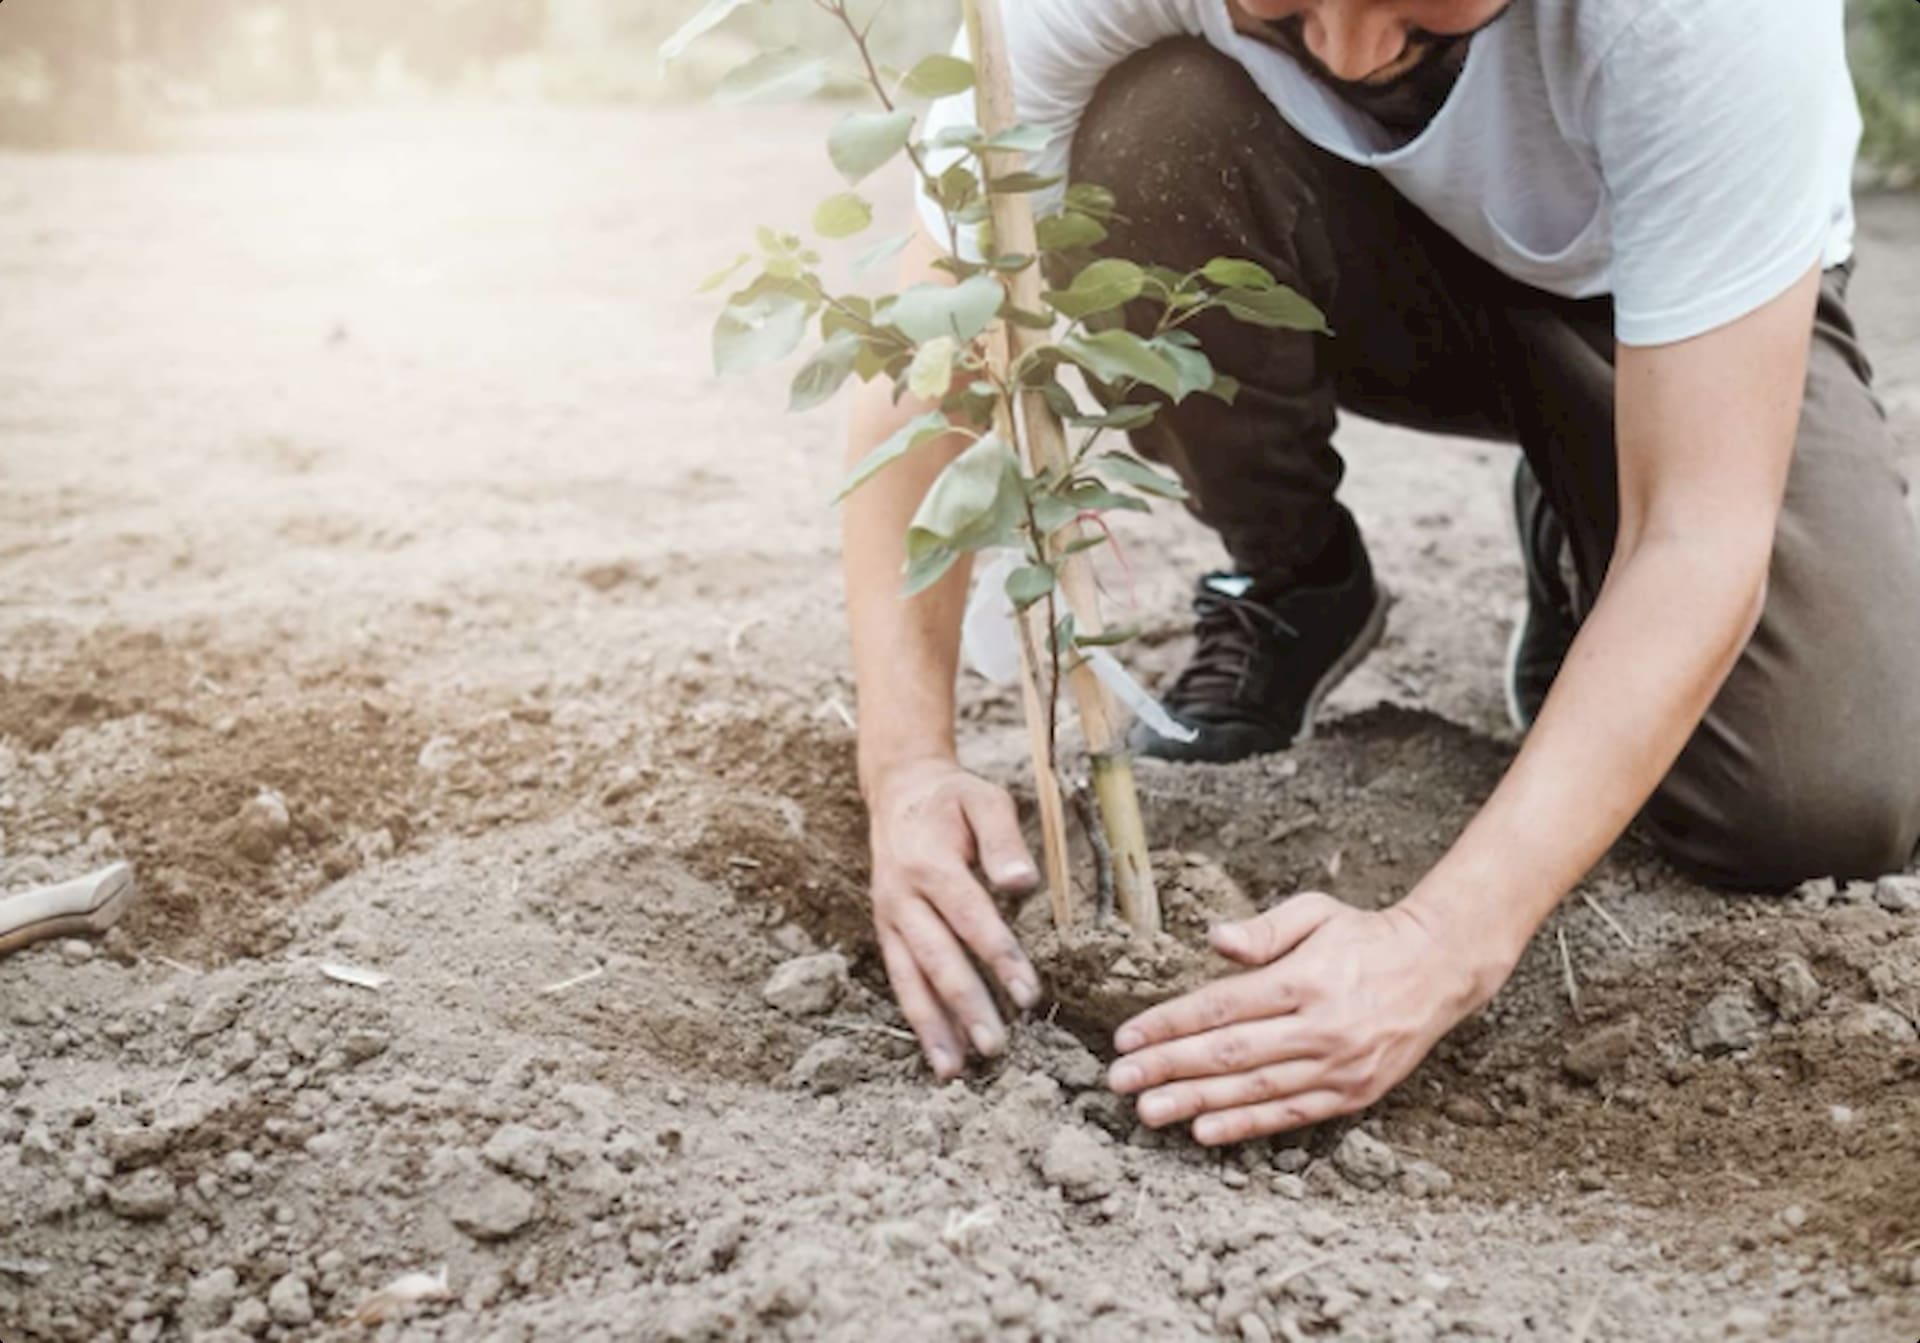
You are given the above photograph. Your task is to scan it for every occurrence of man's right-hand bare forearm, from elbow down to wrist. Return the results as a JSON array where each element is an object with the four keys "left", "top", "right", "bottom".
[{"left": 1404, "top": 534, "right": 1768, "bottom": 1007}]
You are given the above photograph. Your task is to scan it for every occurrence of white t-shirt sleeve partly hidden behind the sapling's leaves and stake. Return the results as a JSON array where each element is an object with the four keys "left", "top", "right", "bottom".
[{"left": 914, "top": 0, "right": 1206, "bottom": 259}]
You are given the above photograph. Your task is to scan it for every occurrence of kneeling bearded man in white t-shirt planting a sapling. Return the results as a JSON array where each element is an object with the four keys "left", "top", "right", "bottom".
[{"left": 847, "top": 0, "right": 1920, "bottom": 1143}]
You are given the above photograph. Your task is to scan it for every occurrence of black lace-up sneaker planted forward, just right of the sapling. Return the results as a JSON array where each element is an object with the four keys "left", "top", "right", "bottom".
[{"left": 1133, "top": 511, "right": 1388, "bottom": 765}]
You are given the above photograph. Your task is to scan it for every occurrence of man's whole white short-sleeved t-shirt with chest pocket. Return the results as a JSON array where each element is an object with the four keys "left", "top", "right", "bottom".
[{"left": 922, "top": 0, "right": 1860, "bottom": 346}]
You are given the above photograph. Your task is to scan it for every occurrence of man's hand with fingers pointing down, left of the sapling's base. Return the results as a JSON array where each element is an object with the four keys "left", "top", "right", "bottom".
[{"left": 870, "top": 757, "right": 1041, "bottom": 1082}]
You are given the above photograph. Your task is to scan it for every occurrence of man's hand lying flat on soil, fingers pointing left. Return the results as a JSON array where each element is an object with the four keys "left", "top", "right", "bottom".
[{"left": 1108, "top": 893, "right": 1511, "bottom": 1147}]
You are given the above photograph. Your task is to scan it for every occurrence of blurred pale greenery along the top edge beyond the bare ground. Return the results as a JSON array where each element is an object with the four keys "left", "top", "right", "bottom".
[{"left": 0, "top": 0, "right": 1920, "bottom": 183}]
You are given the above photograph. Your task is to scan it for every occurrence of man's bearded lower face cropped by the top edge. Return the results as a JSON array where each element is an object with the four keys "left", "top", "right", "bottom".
[{"left": 1227, "top": 0, "right": 1511, "bottom": 88}]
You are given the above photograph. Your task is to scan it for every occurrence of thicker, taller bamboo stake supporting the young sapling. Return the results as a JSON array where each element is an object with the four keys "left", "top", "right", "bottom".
[{"left": 962, "top": 0, "right": 1160, "bottom": 934}]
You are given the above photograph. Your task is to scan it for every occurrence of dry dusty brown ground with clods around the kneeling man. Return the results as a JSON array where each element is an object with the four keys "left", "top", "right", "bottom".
[{"left": 0, "top": 110, "right": 1920, "bottom": 1343}]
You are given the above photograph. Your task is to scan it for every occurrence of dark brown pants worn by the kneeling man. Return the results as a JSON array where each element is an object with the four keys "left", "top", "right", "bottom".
[{"left": 1073, "top": 40, "right": 1920, "bottom": 888}]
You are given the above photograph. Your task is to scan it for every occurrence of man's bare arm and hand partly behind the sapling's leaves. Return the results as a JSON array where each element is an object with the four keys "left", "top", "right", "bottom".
[{"left": 843, "top": 222, "right": 1041, "bottom": 1080}]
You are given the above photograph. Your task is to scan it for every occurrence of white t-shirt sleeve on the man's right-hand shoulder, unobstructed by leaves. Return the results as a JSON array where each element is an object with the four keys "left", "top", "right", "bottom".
[{"left": 1592, "top": 0, "right": 1859, "bottom": 346}]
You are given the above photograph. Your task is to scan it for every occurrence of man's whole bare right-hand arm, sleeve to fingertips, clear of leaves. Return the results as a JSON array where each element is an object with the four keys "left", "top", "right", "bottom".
[{"left": 1110, "top": 271, "right": 1820, "bottom": 1143}]
